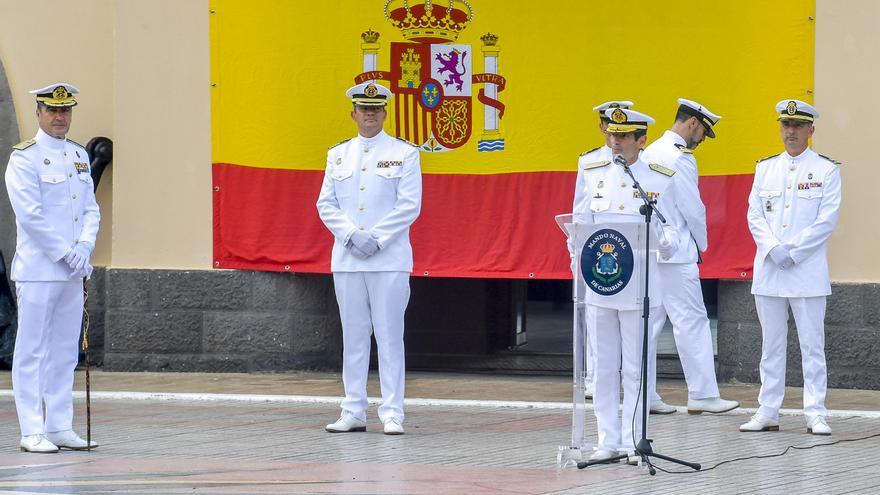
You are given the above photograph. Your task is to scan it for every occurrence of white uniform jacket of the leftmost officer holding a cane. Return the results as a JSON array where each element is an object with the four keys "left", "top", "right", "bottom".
[{"left": 6, "top": 129, "right": 101, "bottom": 282}]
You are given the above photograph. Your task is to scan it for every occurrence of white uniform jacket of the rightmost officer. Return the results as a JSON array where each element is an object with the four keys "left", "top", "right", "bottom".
[{"left": 748, "top": 148, "right": 840, "bottom": 297}]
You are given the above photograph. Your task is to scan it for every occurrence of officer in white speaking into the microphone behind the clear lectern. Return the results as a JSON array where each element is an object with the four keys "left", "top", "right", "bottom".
[{"left": 581, "top": 108, "right": 676, "bottom": 460}]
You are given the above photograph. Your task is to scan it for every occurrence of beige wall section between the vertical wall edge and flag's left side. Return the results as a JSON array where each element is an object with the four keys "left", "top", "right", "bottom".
[{"left": 113, "top": 0, "right": 212, "bottom": 269}]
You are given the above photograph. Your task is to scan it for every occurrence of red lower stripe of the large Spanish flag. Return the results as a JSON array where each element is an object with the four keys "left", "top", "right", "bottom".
[{"left": 213, "top": 164, "right": 755, "bottom": 279}]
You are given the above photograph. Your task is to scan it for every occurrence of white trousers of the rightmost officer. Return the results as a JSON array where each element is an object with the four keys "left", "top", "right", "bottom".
[{"left": 755, "top": 295, "right": 828, "bottom": 424}]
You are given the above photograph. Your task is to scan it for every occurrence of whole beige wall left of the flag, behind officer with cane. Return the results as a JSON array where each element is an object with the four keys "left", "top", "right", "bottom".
[{"left": 0, "top": 0, "right": 212, "bottom": 269}]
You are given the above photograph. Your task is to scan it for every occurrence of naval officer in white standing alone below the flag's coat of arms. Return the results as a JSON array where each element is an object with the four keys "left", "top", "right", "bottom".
[{"left": 317, "top": 82, "right": 422, "bottom": 435}]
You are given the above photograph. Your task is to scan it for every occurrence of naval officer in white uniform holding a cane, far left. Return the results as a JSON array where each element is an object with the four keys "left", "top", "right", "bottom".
[{"left": 6, "top": 83, "right": 101, "bottom": 453}]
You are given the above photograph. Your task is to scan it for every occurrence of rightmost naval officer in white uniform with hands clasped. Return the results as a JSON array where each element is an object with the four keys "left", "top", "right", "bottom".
[{"left": 739, "top": 100, "right": 840, "bottom": 435}]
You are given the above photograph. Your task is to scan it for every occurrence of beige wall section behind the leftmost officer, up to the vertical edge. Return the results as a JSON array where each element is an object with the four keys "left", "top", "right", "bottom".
[{"left": 0, "top": 0, "right": 115, "bottom": 265}]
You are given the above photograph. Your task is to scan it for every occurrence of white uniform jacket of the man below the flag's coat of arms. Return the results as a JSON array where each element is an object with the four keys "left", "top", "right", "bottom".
[{"left": 317, "top": 131, "right": 422, "bottom": 272}]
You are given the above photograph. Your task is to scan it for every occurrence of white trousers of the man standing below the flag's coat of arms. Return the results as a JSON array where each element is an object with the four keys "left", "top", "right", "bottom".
[{"left": 333, "top": 272, "right": 410, "bottom": 422}]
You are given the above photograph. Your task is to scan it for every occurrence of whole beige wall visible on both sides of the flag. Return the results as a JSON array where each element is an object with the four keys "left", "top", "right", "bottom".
[{"left": 0, "top": 0, "right": 880, "bottom": 282}]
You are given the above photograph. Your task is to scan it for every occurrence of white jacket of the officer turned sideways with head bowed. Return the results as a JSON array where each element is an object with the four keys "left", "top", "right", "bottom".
[{"left": 642, "top": 131, "right": 708, "bottom": 263}]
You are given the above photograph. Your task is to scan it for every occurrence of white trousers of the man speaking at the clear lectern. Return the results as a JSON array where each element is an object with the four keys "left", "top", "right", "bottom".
[{"left": 587, "top": 305, "right": 655, "bottom": 450}]
